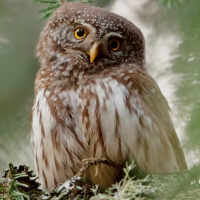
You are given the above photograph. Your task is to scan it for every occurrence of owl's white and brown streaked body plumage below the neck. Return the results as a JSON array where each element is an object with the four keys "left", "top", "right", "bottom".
[{"left": 32, "top": 67, "right": 188, "bottom": 191}]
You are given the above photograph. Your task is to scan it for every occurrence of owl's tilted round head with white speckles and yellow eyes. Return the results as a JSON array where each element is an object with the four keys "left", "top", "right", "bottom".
[{"left": 37, "top": 2, "right": 145, "bottom": 72}]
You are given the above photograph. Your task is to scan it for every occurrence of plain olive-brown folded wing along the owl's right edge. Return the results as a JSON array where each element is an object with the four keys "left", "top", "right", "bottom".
[{"left": 129, "top": 69, "right": 187, "bottom": 170}]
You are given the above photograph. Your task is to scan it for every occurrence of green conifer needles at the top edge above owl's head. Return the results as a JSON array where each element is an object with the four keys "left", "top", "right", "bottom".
[{"left": 35, "top": 0, "right": 93, "bottom": 19}]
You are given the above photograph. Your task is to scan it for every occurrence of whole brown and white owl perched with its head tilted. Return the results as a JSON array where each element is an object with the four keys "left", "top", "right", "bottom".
[{"left": 31, "top": 2, "right": 187, "bottom": 190}]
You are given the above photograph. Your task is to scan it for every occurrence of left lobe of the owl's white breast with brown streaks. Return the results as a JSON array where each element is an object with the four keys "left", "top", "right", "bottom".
[{"left": 31, "top": 88, "right": 86, "bottom": 190}]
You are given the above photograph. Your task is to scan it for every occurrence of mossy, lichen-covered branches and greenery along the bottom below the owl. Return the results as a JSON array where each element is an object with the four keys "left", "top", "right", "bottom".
[{"left": 0, "top": 164, "right": 200, "bottom": 200}]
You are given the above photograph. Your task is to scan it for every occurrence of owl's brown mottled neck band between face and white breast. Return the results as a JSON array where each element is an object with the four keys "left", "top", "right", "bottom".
[{"left": 35, "top": 48, "right": 141, "bottom": 92}]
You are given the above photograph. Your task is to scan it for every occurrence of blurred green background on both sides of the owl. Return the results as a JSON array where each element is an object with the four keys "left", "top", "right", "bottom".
[{"left": 0, "top": 0, "right": 200, "bottom": 175}]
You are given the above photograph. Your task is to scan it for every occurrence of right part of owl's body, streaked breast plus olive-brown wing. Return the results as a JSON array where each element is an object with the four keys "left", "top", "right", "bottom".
[{"left": 78, "top": 66, "right": 187, "bottom": 174}]
